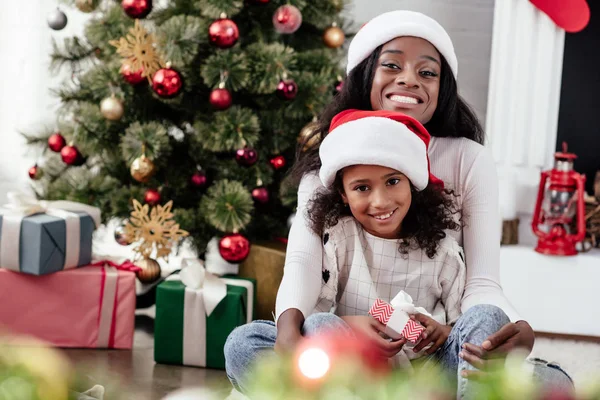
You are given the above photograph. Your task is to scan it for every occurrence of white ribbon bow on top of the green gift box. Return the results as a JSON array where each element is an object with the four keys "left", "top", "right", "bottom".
[{"left": 167, "top": 258, "right": 227, "bottom": 317}]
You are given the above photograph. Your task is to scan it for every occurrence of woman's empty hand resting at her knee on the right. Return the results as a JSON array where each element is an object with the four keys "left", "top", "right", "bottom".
[{"left": 459, "top": 321, "right": 535, "bottom": 379}]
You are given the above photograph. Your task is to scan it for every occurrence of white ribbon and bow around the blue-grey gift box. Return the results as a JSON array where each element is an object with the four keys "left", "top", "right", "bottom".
[{"left": 0, "top": 192, "right": 101, "bottom": 271}]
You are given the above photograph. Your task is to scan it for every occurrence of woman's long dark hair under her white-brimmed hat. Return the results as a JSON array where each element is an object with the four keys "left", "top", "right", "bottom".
[{"left": 290, "top": 45, "right": 484, "bottom": 185}]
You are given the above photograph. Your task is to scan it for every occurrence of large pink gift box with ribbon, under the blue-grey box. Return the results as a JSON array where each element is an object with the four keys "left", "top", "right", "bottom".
[{"left": 0, "top": 266, "right": 135, "bottom": 349}]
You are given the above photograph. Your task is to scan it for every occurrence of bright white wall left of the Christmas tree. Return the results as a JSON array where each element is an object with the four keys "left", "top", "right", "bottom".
[{"left": 0, "top": 0, "right": 86, "bottom": 204}]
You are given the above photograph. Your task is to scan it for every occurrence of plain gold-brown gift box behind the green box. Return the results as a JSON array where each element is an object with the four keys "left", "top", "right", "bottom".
[{"left": 240, "top": 241, "right": 286, "bottom": 320}]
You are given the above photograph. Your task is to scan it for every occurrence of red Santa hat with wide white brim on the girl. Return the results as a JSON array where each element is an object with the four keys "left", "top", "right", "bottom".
[{"left": 319, "top": 110, "right": 444, "bottom": 191}]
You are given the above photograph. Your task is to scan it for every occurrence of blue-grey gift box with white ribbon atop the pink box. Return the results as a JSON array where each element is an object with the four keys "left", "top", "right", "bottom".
[{"left": 0, "top": 193, "right": 100, "bottom": 275}]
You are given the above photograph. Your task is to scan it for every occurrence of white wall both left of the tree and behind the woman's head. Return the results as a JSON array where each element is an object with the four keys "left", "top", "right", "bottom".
[{"left": 0, "top": 0, "right": 494, "bottom": 204}]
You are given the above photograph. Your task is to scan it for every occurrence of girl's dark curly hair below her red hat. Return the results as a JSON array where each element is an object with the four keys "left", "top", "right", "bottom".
[{"left": 306, "top": 171, "right": 461, "bottom": 258}]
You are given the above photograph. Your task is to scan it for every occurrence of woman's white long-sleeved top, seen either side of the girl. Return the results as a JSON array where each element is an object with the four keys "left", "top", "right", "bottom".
[{"left": 276, "top": 138, "right": 520, "bottom": 322}]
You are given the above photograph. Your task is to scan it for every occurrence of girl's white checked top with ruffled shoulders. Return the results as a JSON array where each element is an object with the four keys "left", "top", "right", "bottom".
[{"left": 314, "top": 217, "right": 466, "bottom": 325}]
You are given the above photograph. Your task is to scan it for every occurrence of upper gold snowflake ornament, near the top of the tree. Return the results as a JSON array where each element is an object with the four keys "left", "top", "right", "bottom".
[{"left": 108, "top": 19, "right": 165, "bottom": 81}]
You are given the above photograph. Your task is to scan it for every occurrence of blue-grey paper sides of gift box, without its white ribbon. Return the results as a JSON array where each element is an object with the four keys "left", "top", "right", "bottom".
[{"left": 0, "top": 211, "right": 95, "bottom": 275}]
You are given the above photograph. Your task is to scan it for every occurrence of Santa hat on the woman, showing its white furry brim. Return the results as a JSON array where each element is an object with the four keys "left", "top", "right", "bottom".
[{"left": 346, "top": 10, "right": 458, "bottom": 79}]
